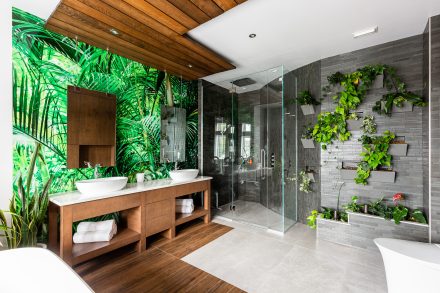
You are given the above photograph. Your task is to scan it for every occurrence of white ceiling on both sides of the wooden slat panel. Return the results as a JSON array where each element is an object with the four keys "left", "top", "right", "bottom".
[{"left": 12, "top": 0, "right": 440, "bottom": 83}]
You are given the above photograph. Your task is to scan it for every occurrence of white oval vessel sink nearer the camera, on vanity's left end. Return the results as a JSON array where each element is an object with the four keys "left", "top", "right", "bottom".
[{"left": 75, "top": 177, "right": 128, "bottom": 195}]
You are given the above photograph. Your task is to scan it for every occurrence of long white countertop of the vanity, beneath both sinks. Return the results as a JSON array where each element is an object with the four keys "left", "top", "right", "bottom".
[{"left": 49, "top": 176, "right": 212, "bottom": 207}]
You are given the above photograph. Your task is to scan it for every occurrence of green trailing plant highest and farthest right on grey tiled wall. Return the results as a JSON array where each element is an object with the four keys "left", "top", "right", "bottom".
[{"left": 373, "top": 66, "right": 427, "bottom": 116}]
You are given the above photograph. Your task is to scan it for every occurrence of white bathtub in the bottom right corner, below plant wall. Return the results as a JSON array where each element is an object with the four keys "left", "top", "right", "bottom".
[{"left": 374, "top": 238, "right": 440, "bottom": 293}]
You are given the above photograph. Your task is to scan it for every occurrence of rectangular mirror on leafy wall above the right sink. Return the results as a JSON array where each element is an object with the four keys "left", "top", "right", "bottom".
[{"left": 160, "top": 106, "right": 186, "bottom": 163}]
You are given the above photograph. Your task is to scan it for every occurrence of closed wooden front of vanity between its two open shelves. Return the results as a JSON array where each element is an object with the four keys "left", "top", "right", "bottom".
[{"left": 145, "top": 199, "right": 174, "bottom": 236}]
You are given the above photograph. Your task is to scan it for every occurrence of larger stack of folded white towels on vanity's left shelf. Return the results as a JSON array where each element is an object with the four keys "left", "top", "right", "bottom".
[{"left": 73, "top": 220, "right": 118, "bottom": 243}]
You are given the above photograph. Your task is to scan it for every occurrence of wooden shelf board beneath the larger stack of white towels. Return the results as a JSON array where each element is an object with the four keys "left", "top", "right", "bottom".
[{"left": 72, "top": 228, "right": 141, "bottom": 265}]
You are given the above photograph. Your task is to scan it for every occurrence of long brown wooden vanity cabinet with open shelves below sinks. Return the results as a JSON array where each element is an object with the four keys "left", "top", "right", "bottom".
[{"left": 49, "top": 177, "right": 212, "bottom": 265}]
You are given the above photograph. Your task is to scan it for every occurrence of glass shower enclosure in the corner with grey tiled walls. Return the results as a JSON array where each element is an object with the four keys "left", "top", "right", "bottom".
[{"left": 201, "top": 67, "right": 297, "bottom": 233}]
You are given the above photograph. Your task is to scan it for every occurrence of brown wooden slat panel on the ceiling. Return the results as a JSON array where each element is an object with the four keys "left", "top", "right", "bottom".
[{"left": 46, "top": 0, "right": 246, "bottom": 80}]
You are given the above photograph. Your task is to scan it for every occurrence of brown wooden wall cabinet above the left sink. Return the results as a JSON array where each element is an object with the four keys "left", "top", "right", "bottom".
[{"left": 67, "top": 86, "right": 116, "bottom": 168}]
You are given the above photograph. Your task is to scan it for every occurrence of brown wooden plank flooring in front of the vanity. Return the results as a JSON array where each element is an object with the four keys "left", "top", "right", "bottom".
[{"left": 75, "top": 221, "right": 244, "bottom": 293}]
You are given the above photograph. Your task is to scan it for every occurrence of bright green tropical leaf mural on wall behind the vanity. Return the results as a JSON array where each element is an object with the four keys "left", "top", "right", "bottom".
[{"left": 12, "top": 8, "right": 198, "bottom": 193}]
